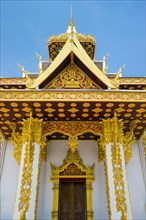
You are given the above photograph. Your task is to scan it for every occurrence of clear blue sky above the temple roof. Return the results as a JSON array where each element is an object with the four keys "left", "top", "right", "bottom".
[{"left": 0, "top": 0, "right": 146, "bottom": 77}]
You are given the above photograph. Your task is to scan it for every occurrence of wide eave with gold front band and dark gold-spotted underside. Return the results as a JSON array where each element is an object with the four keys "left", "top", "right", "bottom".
[{"left": 0, "top": 89, "right": 146, "bottom": 139}]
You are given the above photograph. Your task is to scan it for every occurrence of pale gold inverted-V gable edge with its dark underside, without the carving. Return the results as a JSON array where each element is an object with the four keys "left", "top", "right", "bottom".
[{"left": 28, "top": 27, "right": 115, "bottom": 89}]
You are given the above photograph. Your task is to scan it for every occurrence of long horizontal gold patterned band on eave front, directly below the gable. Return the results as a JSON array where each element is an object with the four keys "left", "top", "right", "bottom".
[{"left": 1, "top": 90, "right": 145, "bottom": 102}]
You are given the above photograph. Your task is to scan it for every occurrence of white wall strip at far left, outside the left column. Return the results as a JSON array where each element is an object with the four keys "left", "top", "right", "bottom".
[{"left": 0, "top": 142, "right": 19, "bottom": 220}]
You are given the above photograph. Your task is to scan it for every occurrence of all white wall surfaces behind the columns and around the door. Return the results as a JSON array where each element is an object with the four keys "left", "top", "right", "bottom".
[{"left": 1, "top": 141, "right": 146, "bottom": 220}]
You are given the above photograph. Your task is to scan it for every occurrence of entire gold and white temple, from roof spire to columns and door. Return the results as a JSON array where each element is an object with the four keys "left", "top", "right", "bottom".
[{"left": 0, "top": 19, "right": 146, "bottom": 220}]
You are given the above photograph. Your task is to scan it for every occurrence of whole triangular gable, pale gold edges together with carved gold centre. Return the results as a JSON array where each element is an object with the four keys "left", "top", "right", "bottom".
[{"left": 29, "top": 33, "right": 114, "bottom": 89}]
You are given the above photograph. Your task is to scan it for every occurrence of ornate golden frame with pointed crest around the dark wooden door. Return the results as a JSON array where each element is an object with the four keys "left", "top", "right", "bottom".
[{"left": 50, "top": 149, "right": 95, "bottom": 220}]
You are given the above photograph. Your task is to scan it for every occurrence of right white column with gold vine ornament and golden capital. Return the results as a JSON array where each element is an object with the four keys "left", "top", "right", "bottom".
[{"left": 99, "top": 112, "right": 133, "bottom": 220}]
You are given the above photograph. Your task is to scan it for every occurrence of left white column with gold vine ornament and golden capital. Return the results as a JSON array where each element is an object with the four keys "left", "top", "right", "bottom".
[{"left": 12, "top": 112, "right": 47, "bottom": 220}]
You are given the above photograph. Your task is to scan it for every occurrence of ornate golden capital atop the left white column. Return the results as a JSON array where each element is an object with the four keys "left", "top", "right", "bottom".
[{"left": 10, "top": 112, "right": 47, "bottom": 164}]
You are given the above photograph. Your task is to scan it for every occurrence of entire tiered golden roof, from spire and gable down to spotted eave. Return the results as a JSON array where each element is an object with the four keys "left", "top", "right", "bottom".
[{"left": 0, "top": 19, "right": 146, "bottom": 139}]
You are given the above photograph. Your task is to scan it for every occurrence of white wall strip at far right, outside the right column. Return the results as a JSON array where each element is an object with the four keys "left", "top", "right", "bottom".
[{"left": 127, "top": 142, "right": 146, "bottom": 220}]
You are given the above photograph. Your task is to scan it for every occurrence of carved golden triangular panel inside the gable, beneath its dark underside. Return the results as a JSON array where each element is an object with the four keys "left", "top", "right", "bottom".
[{"left": 45, "top": 63, "right": 98, "bottom": 89}]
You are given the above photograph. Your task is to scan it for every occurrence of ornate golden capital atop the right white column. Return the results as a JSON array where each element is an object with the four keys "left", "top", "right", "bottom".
[{"left": 98, "top": 111, "right": 136, "bottom": 164}]
